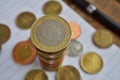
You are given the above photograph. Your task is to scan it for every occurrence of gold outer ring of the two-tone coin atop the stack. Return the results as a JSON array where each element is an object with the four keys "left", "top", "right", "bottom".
[{"left": 30, "top": 15, "right": 71, "bottom": 52}]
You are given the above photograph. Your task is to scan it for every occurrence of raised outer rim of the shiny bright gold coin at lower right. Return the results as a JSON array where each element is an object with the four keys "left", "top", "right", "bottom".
[{"left": 80, "top": 51, "right": 103, "bottom": 74}]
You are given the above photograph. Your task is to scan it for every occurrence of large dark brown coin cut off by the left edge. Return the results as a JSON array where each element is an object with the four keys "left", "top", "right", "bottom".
[{"left": 0, "top": 24, "right": 11, "bottom": 44}]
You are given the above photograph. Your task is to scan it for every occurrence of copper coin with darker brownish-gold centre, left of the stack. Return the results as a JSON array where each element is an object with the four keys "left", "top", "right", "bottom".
[{"left": 13, "top": 41, "right": 37, "bottom": 64}]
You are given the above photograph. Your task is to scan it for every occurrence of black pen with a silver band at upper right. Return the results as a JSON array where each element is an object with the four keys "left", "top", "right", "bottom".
[{"left": 71, "top": 0, "right": 120, "bottom": 36}]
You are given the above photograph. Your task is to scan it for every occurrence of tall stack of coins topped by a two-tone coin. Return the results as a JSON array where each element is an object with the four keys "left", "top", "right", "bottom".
[{"left": 31, "top": 15, "right": 71, "bottom": 71}]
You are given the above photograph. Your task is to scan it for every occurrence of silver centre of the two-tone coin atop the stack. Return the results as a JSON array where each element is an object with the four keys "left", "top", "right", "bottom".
[{"left": 37, "top": 20, "right": 65, "bottom": 46}]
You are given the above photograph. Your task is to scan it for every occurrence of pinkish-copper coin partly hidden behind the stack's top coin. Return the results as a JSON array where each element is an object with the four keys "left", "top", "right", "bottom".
[{"left": 69, "top": 21, "right": 81, "bottom": 40}]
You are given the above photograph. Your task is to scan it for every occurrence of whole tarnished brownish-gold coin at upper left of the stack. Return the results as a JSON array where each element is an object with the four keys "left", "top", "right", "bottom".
[{"left": 16, "top": 12, "right": 36, "bottom": 29}]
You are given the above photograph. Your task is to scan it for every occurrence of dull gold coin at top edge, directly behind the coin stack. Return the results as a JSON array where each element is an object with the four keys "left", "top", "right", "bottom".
[{"left": 43, "top": 1, "right": 62, "bottom": 15}]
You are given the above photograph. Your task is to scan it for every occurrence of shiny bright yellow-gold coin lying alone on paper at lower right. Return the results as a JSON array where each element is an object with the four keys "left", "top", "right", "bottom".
[{"left": 80, "top": 52, "right": 103, "bottom": 74}]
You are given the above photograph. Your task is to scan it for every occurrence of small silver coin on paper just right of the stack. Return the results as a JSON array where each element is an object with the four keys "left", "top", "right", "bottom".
[{"left": 67, "top": 40, "right": 83, "bottom": 57}]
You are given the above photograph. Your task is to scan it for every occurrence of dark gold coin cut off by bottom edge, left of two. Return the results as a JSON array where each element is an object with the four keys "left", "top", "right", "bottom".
[{"left": 25, "top": 69, "right": 48, "bottom": 80}]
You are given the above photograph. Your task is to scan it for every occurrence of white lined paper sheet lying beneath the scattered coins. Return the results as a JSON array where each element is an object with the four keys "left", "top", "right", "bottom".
[{"left": 0, "top": 0, "right": 120, "bottom": 80}]
